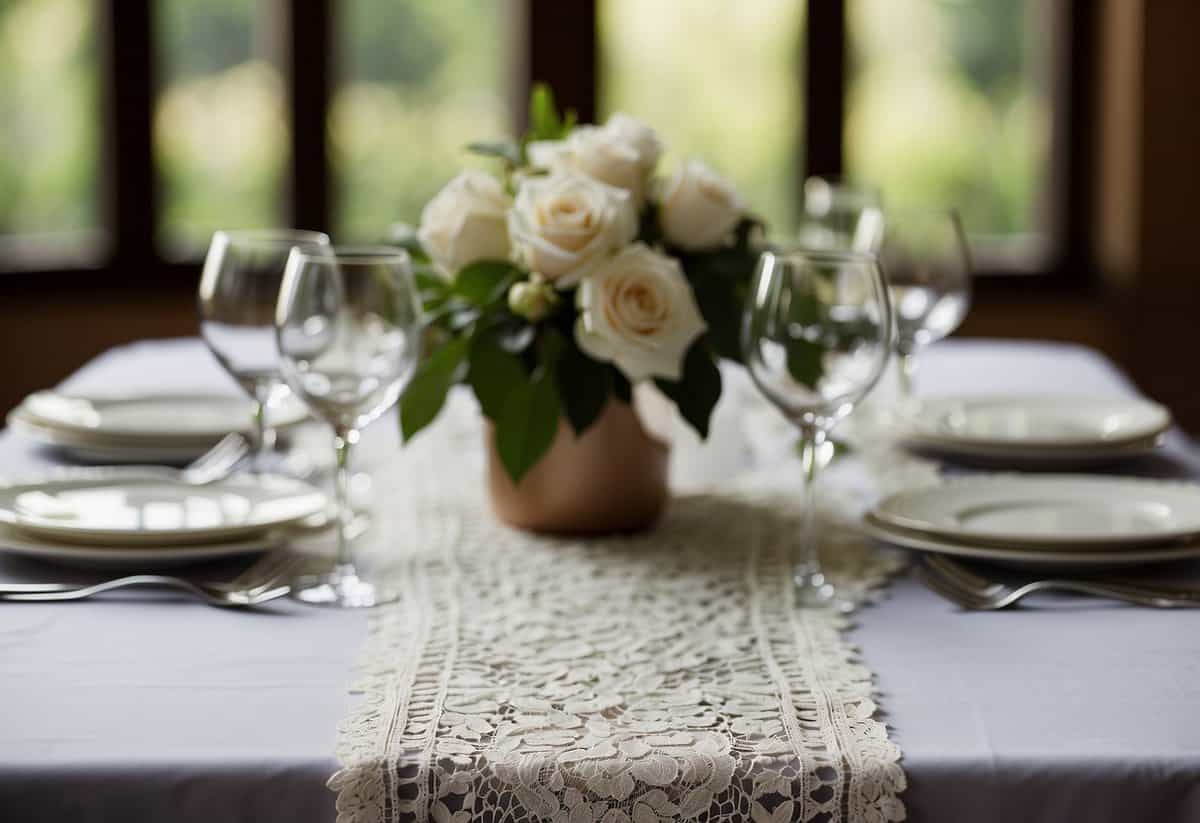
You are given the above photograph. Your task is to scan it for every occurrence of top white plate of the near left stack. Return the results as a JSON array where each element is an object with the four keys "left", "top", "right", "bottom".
[{"left": 0, "top": 475, "right": 326, "bottom": 546}]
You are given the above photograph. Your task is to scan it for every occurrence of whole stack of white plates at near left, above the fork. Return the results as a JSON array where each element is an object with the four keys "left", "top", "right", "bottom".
[{"left": 0, "top": 470, "right": 326, "bottom": 566}]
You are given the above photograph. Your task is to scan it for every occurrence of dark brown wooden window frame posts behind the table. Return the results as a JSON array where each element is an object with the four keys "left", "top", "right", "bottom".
[{"left": 0, "top": 0, "right": 1098, "bottom": 294}]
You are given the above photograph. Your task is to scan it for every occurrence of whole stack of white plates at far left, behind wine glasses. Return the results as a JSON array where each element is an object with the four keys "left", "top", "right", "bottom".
[{"left": 8, "top": 391, "right": 305, "bottom": 463}]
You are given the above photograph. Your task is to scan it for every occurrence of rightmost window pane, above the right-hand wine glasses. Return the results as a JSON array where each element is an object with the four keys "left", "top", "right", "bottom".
[{"left": 846, "top": 0, "right": 1050, "bottom": 254}]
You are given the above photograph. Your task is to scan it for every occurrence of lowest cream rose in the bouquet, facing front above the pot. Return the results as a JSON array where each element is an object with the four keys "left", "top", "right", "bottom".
[{"left": 575, "top": 244, "right": 707, "bottom": 382}]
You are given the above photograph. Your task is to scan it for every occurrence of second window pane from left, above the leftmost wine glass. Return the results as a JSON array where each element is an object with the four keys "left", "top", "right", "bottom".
[{"left": 154, "top": 0, "right": 290, "bottom": 254}]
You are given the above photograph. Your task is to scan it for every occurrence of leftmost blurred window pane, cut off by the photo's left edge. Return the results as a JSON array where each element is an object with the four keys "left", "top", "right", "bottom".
[{"left": 0, "top": 0, "right": 100, "bottom": 262}]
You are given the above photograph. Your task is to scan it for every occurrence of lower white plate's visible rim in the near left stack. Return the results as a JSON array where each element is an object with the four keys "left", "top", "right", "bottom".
[{"left": 0, "top": 524, "right": 288, "bottom": 570}]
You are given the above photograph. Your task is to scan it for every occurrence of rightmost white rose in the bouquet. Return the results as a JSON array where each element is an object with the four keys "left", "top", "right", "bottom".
[{"left": 659, "top": 160, "right": 745, "bottom": 251}]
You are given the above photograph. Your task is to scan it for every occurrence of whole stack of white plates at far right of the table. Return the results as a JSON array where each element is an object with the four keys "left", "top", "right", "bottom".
[{"left": 904, "top": 395, "right": 1171, "bottom": 465}]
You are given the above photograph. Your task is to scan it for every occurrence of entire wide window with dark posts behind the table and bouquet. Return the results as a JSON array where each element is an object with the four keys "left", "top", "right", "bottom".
[{"left": 0, "top": 0, "right": 1092, "bottom": 289}]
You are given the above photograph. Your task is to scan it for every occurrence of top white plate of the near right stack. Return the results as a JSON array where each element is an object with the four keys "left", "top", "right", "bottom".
[{"left": 871, "top": 474, "right": 1200, "bottom": 551}]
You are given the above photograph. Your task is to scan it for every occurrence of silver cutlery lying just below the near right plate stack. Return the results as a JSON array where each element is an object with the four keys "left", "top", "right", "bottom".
[{"left": 918, "top": 555, "right": 1200, "bottom": 611}]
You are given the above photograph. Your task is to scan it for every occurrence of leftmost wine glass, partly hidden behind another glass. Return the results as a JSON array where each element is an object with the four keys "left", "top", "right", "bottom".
[{"left": 198, "top": 229, "right": 329, "bottom": 471}]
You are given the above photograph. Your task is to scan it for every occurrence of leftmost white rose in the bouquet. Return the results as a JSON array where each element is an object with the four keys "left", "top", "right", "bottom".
[{"left": 416, "top": 169, "right": 509, "bottom": 277}]
